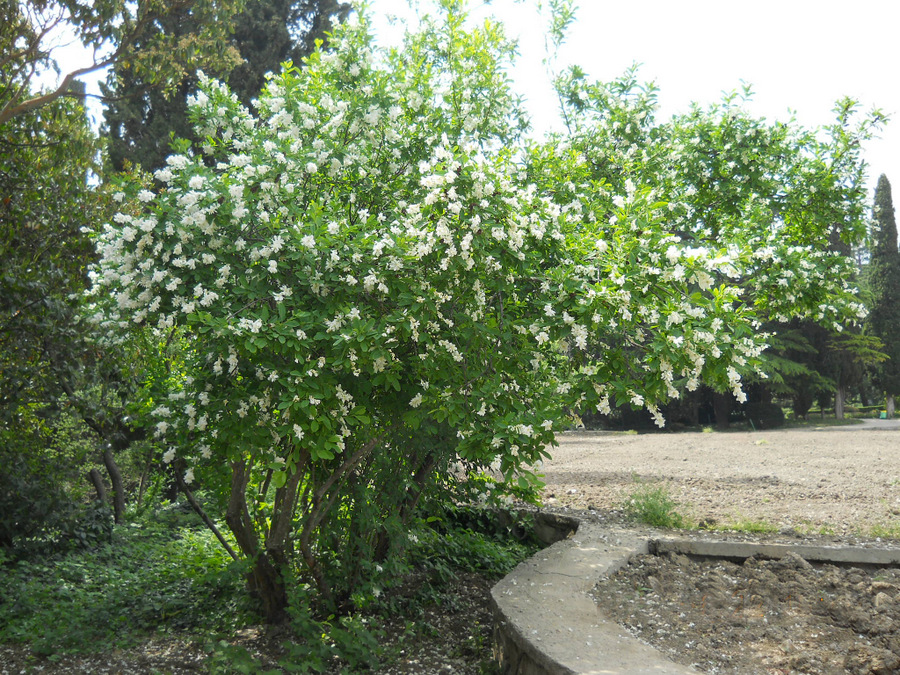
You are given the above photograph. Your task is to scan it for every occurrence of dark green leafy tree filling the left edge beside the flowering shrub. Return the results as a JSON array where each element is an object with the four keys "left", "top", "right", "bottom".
[{"left": 0, "top": 78, "right": 131, "bottom": 545}]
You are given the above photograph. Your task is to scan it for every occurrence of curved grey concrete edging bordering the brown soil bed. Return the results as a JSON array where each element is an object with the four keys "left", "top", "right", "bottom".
[{"left": 491, "top": 517, "right": 900, "bottom": 675}]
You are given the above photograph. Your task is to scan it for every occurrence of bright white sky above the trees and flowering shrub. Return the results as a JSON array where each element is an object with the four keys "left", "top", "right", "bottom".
[{"left": 61, "top": 0, "right": 900, "bottom": 203}]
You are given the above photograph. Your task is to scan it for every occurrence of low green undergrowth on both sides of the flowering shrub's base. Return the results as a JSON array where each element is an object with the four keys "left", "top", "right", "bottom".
[{"left": 0, "top": 507, "right": 538, "bottom": 673}]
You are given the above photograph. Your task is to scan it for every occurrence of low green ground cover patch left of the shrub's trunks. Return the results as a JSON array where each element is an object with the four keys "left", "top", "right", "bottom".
[{"left": 0, "top": 522, "right": 252, "bottom": 654}]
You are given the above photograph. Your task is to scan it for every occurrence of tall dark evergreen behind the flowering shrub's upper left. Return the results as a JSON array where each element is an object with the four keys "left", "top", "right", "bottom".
[{"left": 103, "top": 0, "right": 350, "bottom": 171}]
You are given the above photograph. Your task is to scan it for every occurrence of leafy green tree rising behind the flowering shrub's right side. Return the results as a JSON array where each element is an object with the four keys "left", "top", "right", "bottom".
[{"left": 557, "top": 68, "right": 885, "bottom": 426}]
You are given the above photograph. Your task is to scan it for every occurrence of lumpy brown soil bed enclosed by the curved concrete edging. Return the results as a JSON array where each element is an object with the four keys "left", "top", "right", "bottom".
[{"left": 593, "top": 554, "right": 900, "bottom": 675}]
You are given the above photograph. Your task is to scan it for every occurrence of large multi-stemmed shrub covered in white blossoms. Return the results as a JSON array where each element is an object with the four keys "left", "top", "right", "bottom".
[{"left": 88, "top": 2, "right": 876, "bottom": 618}]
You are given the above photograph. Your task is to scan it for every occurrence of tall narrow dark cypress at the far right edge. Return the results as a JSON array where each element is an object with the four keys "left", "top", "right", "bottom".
[{"left": 868, "top": 174, "right": 900, "bottom": 415}]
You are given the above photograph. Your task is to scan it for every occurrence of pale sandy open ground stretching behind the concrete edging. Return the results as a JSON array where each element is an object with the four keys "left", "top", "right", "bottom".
[{"left": 542, "top": 420, "right": 900, "bottom": 535}]
